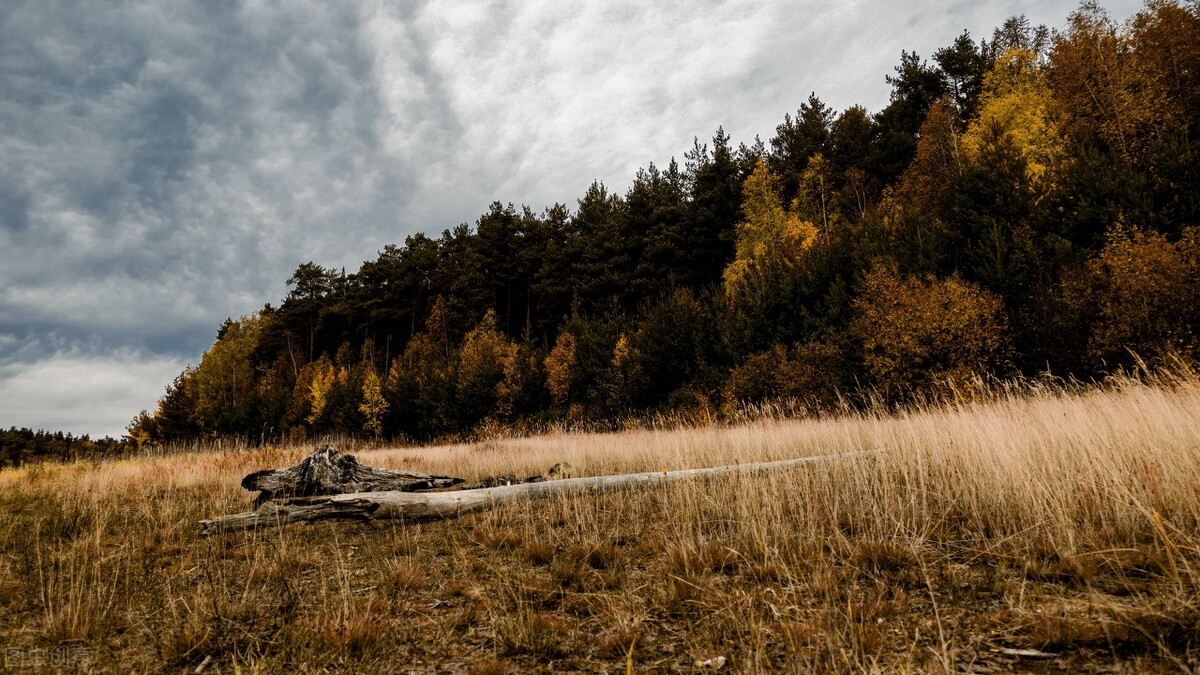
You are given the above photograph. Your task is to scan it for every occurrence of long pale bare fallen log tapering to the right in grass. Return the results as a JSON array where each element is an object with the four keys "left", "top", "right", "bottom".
[{"left": 200, "top": 453, "right": 874, "bottom": 536}]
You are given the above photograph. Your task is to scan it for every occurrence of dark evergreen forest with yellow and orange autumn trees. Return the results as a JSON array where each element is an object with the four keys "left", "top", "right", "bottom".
[{"left": 127, "top": 0, "right": 1200, "bottom": 447}]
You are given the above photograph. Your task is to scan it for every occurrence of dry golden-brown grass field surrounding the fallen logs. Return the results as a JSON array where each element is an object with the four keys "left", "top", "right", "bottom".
[{"left": 0, "top": 375, "right": 1200, "bottom": 673}]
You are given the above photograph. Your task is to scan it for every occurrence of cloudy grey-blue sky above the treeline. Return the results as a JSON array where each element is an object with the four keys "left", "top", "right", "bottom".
[{"left": 0, "top": 0, "right": 1140, "bottom": 437}]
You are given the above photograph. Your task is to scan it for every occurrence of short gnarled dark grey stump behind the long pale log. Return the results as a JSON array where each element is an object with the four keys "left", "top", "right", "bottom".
[{"left": 241, "top": 446, "right": 462, "bottom": 508}]
